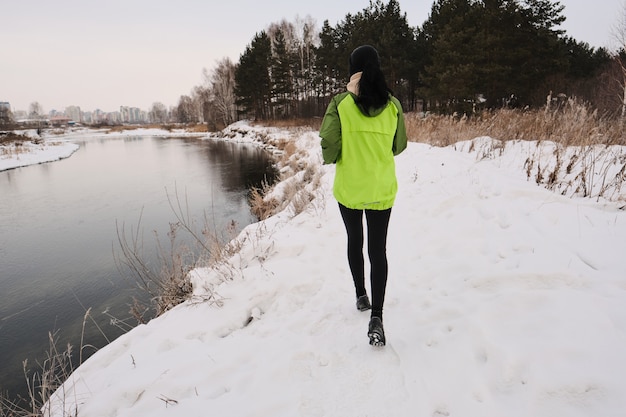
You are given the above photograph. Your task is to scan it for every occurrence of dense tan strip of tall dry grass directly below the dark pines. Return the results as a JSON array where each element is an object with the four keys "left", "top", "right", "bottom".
[{"left": 405, "top": 99, "right": 626, "bottom": 146}]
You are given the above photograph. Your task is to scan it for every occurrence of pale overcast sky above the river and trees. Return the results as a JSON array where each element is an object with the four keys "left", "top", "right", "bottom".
[{"left": 0, "top": 0, "right": 625, "bottom": 112}]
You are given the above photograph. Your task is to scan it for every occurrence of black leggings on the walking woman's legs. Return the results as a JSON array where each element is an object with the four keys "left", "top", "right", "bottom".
[{"left": 339, "top": 203, "right": 391, "bottom": 318}]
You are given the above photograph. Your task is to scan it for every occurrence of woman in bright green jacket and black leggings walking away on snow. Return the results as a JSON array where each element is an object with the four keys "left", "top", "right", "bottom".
[{"left": 319, "top": 45, "right": 407, "bottom": 346}]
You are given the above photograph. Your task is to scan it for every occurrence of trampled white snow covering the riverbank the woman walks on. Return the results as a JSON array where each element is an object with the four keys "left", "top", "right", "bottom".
[{"left": 4, "top": 124, "right": 626, "bottom": 417}]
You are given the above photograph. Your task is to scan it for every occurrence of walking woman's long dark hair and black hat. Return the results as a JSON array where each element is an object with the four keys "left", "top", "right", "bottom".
[{"left": 350, "top": 45, "right": 392, "bottom": 114}]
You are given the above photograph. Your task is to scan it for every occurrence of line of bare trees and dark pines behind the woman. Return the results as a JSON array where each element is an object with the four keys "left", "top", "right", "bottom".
[{"left": 169, "top": 0, "right": 626, "bottom": 128}]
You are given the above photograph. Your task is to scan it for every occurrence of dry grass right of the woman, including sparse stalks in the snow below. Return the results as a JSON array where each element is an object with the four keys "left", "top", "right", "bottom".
[{"left": 406, "top": 99, "right": 626, "bottom": 201}]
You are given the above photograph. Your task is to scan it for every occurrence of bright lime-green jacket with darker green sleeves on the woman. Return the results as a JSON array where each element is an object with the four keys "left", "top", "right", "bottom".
[{"left": 319, "top": 92, "right": 407, "bottom": 210}]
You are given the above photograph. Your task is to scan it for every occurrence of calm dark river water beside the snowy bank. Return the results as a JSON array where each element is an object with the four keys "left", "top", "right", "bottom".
[{"left": 0, "top": 136, "right": 275, "bottom": 397}]
